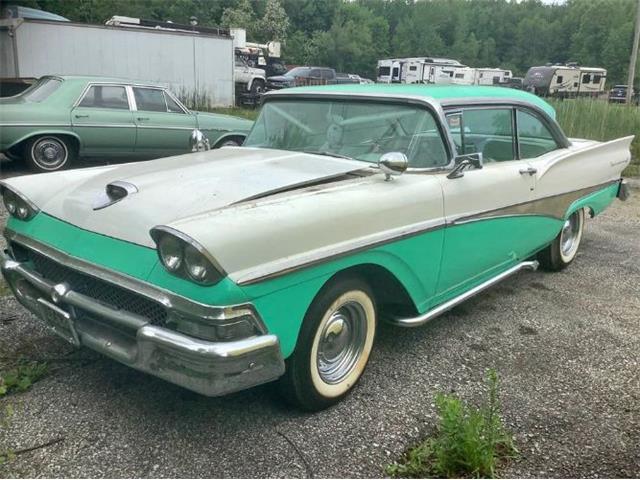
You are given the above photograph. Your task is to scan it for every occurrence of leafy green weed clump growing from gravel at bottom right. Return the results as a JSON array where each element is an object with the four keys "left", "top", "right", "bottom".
[{"left": 386, "top": 370, "right": 517, "bottom": 478}]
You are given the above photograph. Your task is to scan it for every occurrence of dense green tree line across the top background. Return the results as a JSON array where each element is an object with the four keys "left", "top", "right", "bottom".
[{"left": 12, "top": 0, "right": 637, "bottom": 85}]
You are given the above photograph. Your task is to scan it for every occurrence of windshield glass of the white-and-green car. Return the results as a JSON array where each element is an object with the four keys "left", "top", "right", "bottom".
[{"left": 243, "top": 100, "right": 449, "bottom": 168}]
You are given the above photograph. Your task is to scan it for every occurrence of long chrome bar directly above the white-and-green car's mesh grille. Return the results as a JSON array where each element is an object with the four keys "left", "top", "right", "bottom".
[{"left": 4, "top": 228, "right": 266, "bottom": 326}]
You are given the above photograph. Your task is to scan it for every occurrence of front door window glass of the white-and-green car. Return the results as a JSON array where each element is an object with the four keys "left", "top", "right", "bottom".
[{"left": 448, "top": 108, "right": 516, "bottom": 163}]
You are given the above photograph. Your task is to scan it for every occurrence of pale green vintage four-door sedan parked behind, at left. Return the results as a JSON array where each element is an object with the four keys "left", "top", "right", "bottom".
[{"left": 0, "top": 76, "right": 253, "bottom": 172}]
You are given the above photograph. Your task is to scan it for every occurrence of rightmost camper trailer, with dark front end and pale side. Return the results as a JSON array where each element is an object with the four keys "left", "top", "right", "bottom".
[{"left": 524, "top": 64, "right": 607, "bottom": 97}]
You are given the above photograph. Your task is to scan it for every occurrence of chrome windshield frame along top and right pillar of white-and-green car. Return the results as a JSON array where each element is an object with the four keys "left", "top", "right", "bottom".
[{"left": 262, "top": 89, "right": 456, "bottom": 173}]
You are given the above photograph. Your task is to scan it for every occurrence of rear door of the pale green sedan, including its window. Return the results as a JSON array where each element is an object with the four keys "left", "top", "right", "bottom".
[{"left": 71, "top": 84, "right": 136, "bottom": 155}]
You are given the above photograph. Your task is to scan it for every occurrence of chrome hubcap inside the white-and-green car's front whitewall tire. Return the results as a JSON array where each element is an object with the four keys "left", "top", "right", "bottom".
[{"left": 317, "top": 302, "right": 367, "bottom": 384}]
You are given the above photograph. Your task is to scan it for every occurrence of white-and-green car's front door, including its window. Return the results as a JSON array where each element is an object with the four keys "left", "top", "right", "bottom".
[{"left": 438, "top": 106, "right": 536, "bottom": 298}]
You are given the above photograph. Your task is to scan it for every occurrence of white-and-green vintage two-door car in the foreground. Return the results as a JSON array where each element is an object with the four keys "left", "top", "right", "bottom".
[{"left": 1, "top": 85, "right": 632, "bottom": 410}]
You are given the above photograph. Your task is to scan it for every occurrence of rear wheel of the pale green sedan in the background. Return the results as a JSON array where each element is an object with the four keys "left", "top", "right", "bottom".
[{"left": 24, "top": 135, "right": 75, "bottom": 172}]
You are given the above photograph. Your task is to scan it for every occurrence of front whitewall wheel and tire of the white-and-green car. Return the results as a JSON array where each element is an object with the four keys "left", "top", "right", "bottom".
[{"left": 280, "top": 278, "right": 376, "bottom": 411}]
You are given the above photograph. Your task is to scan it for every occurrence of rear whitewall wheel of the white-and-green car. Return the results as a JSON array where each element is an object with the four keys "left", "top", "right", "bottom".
[{"left": 538, "top": 209, "right": 584, "bottom": 272}]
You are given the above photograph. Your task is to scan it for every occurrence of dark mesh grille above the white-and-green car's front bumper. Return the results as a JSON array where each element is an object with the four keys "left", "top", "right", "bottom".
[{"left": 16, "top": 246, "right": 167, "bottom": 325}]
